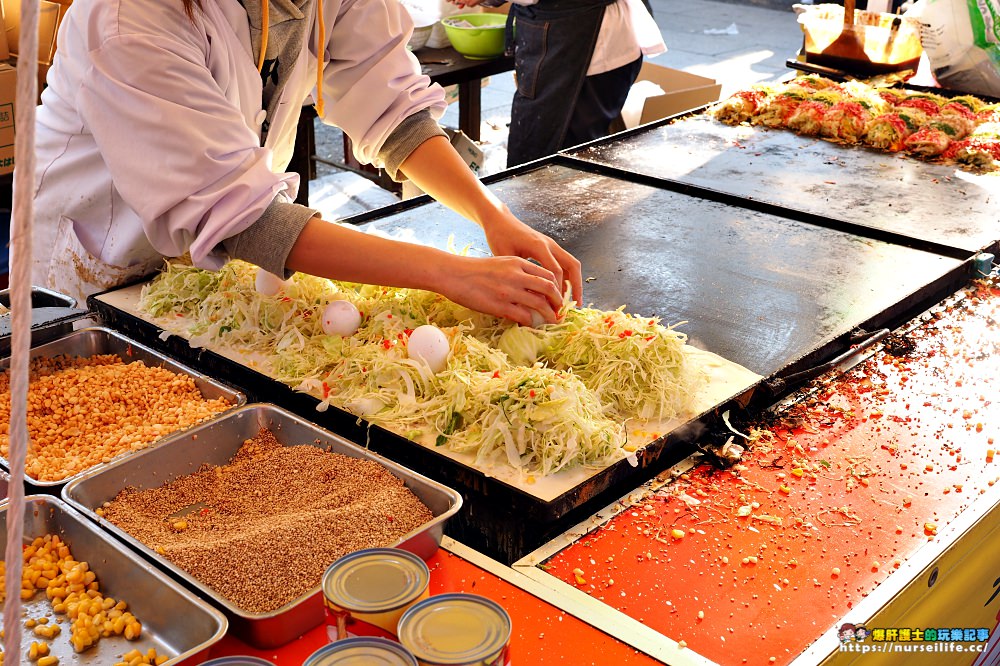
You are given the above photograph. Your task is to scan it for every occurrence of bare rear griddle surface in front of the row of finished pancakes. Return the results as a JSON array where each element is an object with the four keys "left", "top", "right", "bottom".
[{"left": 568, "top": 114, "right": 1000, "bottom": 253}]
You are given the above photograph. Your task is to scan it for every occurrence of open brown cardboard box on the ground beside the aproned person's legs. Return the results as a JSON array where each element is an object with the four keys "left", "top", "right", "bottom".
[{"left": 621, "top": 62, "right": 722, "bottom": 129}]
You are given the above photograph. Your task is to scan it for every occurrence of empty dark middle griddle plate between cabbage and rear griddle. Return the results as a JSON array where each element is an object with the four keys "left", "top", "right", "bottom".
[{"left": 358, "top": 161, "right": 962, "bottom": 377}]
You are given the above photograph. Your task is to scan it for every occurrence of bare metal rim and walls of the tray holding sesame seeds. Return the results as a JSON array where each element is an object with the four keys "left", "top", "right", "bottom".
[{"left": 62, "top": 404, "right": 462, "bottom": 648}]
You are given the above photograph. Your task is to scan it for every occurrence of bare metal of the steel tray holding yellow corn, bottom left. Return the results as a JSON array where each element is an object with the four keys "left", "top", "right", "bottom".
[{"left": 0, "top": 495, "right": 227, "bottom": 666}]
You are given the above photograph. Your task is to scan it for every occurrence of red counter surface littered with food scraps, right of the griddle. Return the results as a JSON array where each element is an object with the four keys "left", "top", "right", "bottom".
[{"left": 544, "top": 278, "right": 1000, "bottom": 665}]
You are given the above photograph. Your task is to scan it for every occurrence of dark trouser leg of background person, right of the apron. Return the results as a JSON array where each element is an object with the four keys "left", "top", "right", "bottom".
[{"left": 559, "top": 56, "right": 642, "bottom": 150}]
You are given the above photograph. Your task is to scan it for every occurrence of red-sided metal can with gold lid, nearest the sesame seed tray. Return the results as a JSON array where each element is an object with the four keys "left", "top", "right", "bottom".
[{"left": 323, "top": 548, "right": 431, "bottom": 640}]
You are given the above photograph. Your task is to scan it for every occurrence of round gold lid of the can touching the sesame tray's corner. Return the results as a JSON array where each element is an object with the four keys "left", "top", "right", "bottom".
[{"left": 323, "top": 548, "right": 430, "bottom": 613}]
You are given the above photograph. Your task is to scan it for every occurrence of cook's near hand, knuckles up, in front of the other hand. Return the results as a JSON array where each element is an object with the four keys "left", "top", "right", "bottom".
[{"left": 434, "top": 255, "right": 561, "bottom": 326}]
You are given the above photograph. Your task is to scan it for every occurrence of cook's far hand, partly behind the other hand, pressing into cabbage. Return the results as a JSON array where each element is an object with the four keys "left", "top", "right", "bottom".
[{"left": 483, "top": 206, "right": 583, "bottom": 310}]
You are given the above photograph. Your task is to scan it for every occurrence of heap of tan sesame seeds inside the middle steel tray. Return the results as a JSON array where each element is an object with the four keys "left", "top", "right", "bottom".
[{"left": 102, "top": 429, "right": 433, "bottom": 613}]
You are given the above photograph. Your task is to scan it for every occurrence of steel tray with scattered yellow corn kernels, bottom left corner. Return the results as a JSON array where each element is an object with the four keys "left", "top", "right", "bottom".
[{"left": 0, "top": 496, "right": 227, "bottom": 666}]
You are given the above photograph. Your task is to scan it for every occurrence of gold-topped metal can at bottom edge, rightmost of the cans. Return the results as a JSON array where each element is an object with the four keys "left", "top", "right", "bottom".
[{"left": 399, "top": 593, "right": 511, "bottom": 666}]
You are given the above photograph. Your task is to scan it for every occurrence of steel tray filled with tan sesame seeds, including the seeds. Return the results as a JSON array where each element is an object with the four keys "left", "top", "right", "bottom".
[{"left": 63, "top": 404, "right": 462, "bottom": 648}]
